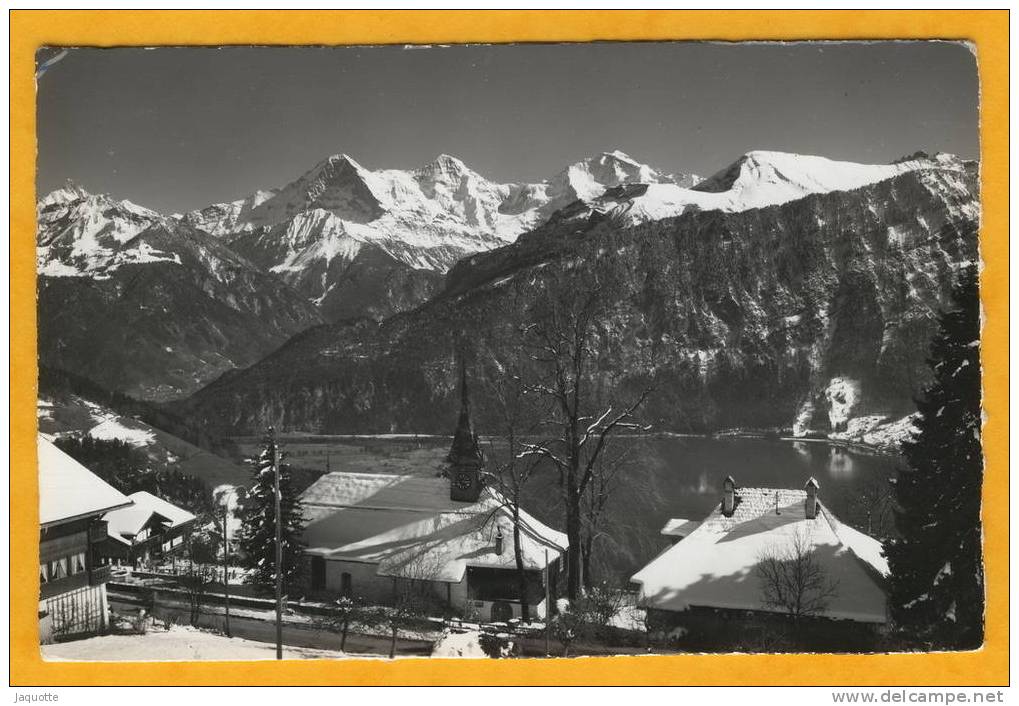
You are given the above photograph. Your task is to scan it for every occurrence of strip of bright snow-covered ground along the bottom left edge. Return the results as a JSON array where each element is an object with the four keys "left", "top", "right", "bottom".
[{"left": 42, "top": 626, "right": 370, "bottom": 662}]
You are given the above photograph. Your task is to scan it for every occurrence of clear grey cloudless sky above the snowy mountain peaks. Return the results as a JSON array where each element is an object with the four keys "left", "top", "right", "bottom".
[{"left": 38, "top": 42, "right": 978, "bottom": 213}]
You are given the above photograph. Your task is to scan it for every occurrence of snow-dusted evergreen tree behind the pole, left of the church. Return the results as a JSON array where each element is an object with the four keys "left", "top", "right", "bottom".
[{"left": 239, "top": 428, "right": 305, "bottom": 590}]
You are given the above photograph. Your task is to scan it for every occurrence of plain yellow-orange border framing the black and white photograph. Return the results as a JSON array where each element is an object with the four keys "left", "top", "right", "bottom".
[{"left": 10, "top": 10, "right": 1009, "bottom": 686}]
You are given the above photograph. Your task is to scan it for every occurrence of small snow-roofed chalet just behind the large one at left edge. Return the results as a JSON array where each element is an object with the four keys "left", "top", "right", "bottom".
[{"left": 99, "top": 490, "right": 196, "bottom": 566}]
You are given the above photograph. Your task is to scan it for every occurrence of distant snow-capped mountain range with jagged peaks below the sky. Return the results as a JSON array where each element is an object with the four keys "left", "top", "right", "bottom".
[{"left": 38, "top": 146, "right": 979, "bottom": 399}]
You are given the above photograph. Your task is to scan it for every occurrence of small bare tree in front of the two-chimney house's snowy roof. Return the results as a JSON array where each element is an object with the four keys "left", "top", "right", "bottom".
[{"left": 754, "top": 529, "right": 839, "bottom": 618}]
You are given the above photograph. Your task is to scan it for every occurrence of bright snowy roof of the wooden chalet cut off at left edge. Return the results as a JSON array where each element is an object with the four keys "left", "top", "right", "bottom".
[{"left": 38, "top": 436, "right": 130, "bottom": 527}]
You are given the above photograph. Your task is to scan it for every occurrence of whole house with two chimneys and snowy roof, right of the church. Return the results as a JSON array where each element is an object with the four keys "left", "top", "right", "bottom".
[{"left": 633, "top": 477, "right": 889, "bottom": 643}]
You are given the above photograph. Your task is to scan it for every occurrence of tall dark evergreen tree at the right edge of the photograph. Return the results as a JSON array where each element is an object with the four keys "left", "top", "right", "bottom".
[{"left": 887, "top": 269, "right": 983, "bottom": 648}]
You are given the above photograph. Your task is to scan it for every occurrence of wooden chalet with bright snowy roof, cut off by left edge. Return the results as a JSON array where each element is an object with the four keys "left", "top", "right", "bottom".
[{"left": 38, "top": 437, "right": 130, "bottom": 642}]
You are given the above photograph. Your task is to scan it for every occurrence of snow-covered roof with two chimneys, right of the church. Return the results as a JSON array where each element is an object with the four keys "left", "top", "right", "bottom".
[{"left": 633, "top": 488, "right": 888, "bottom": 622}]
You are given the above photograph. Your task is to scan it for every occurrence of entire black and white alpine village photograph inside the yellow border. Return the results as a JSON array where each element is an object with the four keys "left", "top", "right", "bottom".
[{"left": 35, "top": 41, "right": 990, "bottom": 662}]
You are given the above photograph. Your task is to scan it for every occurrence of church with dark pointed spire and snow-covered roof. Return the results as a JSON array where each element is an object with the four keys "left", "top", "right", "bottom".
[{"left": 301, "top": 370, "right": 568, "bottom": 621}]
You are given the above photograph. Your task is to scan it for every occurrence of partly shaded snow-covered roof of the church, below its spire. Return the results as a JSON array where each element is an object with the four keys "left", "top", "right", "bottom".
[{"left": 302, "top": 473, "right": 568, "bottom": 583}]
